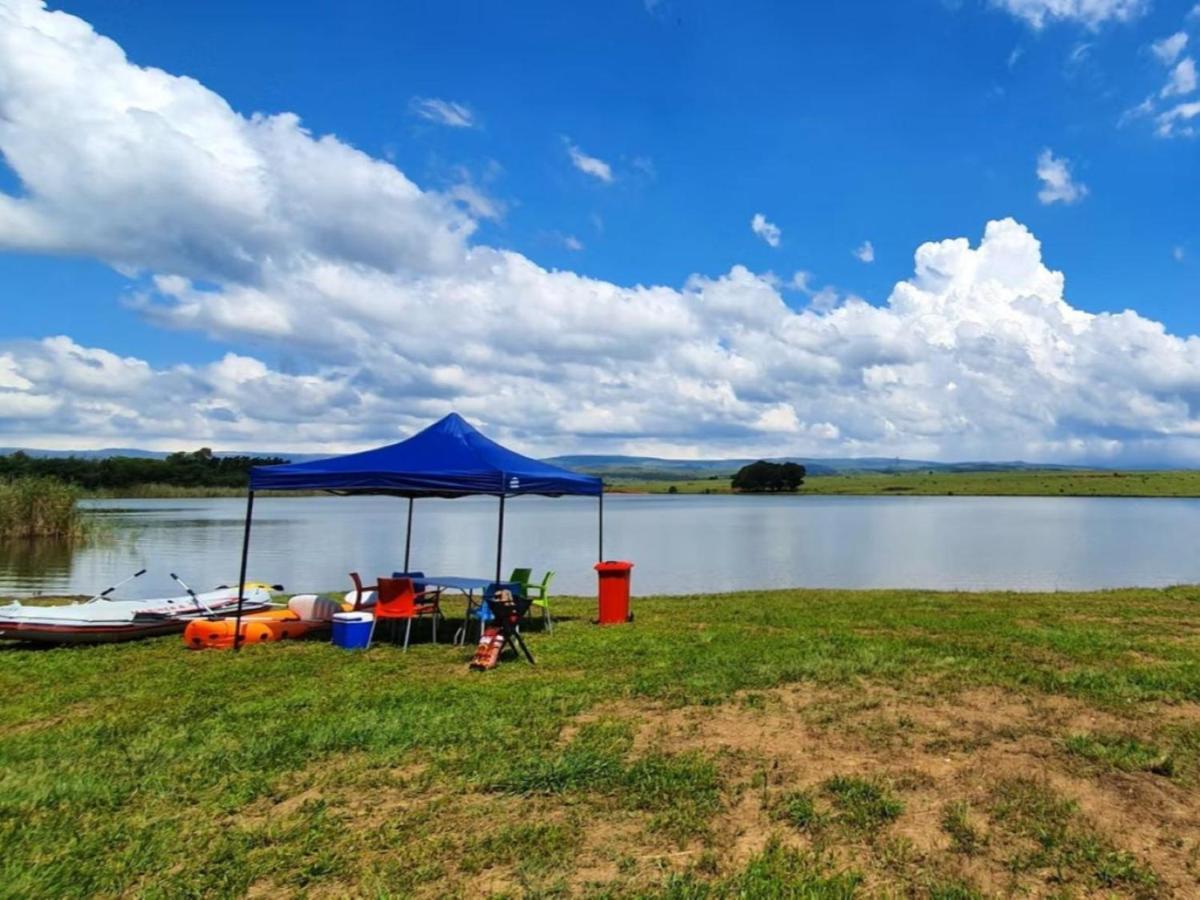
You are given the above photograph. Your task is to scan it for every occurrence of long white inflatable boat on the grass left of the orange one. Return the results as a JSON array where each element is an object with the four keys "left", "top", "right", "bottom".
[{"left": 0, "top": 582, "right": 271, "bottom": 643}]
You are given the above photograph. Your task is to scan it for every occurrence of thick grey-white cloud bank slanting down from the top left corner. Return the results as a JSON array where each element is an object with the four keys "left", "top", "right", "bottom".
[{"left": 0, "top": 0, "right": 475, "bottom": 280}]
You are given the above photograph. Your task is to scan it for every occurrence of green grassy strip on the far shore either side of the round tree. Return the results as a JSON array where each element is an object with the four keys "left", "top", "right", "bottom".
[{"left": 611, "top": 469, "right": 1200, "bottom": 497}]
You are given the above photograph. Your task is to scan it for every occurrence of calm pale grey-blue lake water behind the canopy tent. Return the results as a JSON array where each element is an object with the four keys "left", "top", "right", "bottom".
[{"left": 0, "top": 494, "right": 1200, "bottom": 596}]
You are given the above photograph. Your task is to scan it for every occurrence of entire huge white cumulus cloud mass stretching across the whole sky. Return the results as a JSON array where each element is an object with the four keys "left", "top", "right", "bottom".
[{"left": 9, "top": 2, "right": 1200, "bottom": 461}]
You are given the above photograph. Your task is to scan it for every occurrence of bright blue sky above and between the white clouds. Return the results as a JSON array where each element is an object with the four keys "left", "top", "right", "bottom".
[{"left": 0, "top": 0, "right": 1200, "bottom": 458}]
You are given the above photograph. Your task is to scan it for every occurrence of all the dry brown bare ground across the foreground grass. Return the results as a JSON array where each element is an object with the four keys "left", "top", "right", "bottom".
[{"left": 242, "top": 684, "right": 1200, "bottom": 896}]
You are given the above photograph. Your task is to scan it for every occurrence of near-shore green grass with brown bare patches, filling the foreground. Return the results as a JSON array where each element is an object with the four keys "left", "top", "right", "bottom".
[{"left": 0, "top": 588, "right": 1200, "bottom": 899}]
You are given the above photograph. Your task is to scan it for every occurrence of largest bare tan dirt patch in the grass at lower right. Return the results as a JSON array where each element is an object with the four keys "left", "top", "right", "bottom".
[{"left": 606, "top": 685, "right": 1200, "bottom": 896}]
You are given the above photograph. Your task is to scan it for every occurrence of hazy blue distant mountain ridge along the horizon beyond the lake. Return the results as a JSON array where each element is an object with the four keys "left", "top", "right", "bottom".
[{"left": 0, "top": 446, "right": 1096, "bottom": 481}]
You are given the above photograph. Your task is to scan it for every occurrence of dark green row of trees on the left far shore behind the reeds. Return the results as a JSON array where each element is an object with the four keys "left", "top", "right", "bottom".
[{"left": 0, "top": 448, "right": 287, "bottom": 491}]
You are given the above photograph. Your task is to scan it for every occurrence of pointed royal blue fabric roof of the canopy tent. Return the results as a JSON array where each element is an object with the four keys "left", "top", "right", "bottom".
[{"left": 250, "top": 413, "right": 604, "bottom": 497}]
